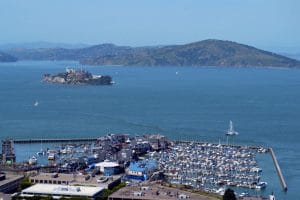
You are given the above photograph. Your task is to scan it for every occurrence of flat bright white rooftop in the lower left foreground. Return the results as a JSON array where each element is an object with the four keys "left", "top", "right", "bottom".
[{"left": 22, "top": 183, "right": 104, "bottom": 197}]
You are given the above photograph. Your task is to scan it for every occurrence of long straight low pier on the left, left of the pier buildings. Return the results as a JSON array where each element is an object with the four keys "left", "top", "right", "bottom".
[{"left": 13, "top": 138, "right": 97, "bottom": 144}]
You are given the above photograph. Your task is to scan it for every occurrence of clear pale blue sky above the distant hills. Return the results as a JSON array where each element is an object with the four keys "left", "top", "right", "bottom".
[{"left": 0, "top": 0, "right": 300, "bottom": 53}]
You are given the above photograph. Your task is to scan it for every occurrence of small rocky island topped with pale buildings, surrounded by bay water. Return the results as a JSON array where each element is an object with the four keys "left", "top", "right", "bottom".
[{"left": 43, "top": 68, "right": 113, "bottom": 85}]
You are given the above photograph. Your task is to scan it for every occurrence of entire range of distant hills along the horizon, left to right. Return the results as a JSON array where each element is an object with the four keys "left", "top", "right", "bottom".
[{"left": 6, "top": 39, "right": 300, "bottom": 67}]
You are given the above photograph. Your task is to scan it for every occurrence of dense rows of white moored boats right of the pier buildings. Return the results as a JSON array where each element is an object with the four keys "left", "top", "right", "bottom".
[{"left": 149, "top": 142, "right": 264, "bottom": 193}]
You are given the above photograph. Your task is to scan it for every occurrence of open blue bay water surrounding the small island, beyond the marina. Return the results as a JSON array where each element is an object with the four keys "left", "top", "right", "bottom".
[{"left": 0, "top": 61, "right": 300, "bottom": 199}]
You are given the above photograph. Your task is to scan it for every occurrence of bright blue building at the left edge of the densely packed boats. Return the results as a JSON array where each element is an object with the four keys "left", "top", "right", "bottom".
[{"left": 125, "top": 159, "right": 157, "bottom": 181}]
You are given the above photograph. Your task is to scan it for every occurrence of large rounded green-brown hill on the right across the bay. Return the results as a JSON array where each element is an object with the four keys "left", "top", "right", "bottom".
[{"left": 81, "top": 40, "right": 300, "bottom": 67}]
